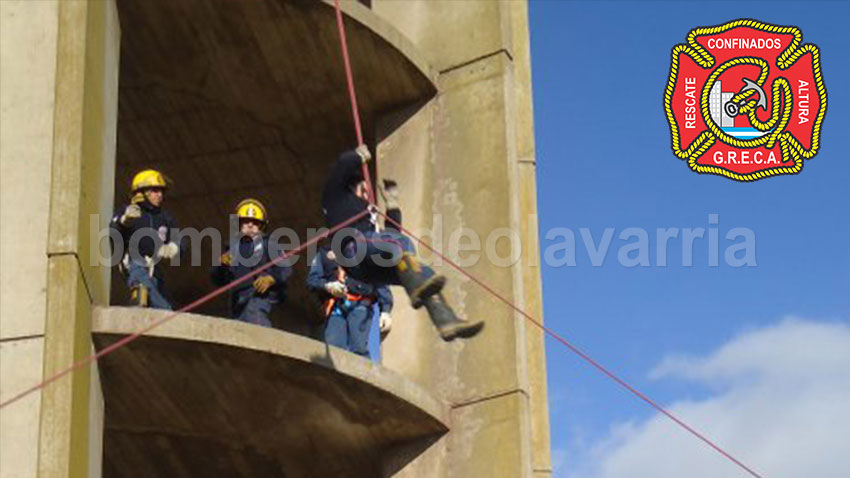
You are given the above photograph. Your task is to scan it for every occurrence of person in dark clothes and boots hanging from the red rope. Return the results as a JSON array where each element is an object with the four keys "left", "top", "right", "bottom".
[{"left": 322, "top": 145, "right": 484, "bottom": 341}]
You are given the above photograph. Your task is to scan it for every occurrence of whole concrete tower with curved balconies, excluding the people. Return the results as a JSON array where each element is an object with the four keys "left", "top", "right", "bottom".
[{"left": 0, "top": 0, "right": 551, "bottom": 478}]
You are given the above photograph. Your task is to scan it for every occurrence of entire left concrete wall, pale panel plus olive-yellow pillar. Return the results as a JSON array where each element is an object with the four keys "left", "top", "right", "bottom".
[{"left": 0, "top": 1, "right": 119, "bottom": 477}]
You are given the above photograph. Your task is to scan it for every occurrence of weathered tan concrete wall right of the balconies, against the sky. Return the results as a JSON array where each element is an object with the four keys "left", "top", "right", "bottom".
[{"left": 373, "top": 0, "right": 551, "bottom": 477}]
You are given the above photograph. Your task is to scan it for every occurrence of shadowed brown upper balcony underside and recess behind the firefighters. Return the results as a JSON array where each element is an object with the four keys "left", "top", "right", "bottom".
[{"left": 112, "top": 0, "right": 437, "bottom": 324}]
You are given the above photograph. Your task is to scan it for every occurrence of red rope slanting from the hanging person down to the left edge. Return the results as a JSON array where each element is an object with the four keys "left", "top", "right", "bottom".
[{"left": 0, "top": 211, "right": 369, "bottom": 409}]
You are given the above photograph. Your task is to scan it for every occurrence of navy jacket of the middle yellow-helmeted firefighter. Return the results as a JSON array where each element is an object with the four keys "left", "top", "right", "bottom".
[{"left": 210, "top": 236, "right": 292, "bottom": 306}]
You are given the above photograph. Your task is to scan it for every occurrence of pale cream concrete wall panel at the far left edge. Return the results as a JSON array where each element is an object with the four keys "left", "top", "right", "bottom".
[{"left": 0, "top": 1, "right": 58, "bottom": 478}]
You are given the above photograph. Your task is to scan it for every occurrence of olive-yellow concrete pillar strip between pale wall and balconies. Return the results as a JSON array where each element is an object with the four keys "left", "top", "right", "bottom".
[{"left": 38, "top": 0, "right": 120, "bottom": 477}]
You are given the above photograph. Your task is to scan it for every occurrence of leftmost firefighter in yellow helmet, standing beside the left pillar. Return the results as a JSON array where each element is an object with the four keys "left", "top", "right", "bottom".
[{"left": 110, "top": 169, "right": 180, "bottom": 310}]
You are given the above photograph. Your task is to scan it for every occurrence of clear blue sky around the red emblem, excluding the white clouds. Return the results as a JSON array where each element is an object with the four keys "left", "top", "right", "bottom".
[{"left": 529, "top": 0, "right": 850, "bottom": 478}]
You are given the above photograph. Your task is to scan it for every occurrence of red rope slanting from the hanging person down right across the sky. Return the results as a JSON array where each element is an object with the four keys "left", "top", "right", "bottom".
[{"left": 378, "top": 211, "right": 764, "bottom": 478}]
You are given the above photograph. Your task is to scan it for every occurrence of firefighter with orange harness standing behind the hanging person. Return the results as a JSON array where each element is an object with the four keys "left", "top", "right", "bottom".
[{"left": 307, "top": 247, "right": 393, "bottom": 357}]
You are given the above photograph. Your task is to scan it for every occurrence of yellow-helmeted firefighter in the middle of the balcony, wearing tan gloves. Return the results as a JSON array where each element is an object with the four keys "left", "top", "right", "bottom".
[{"left": 211, "top": 198, "right": 292, "bottom": 327}]
